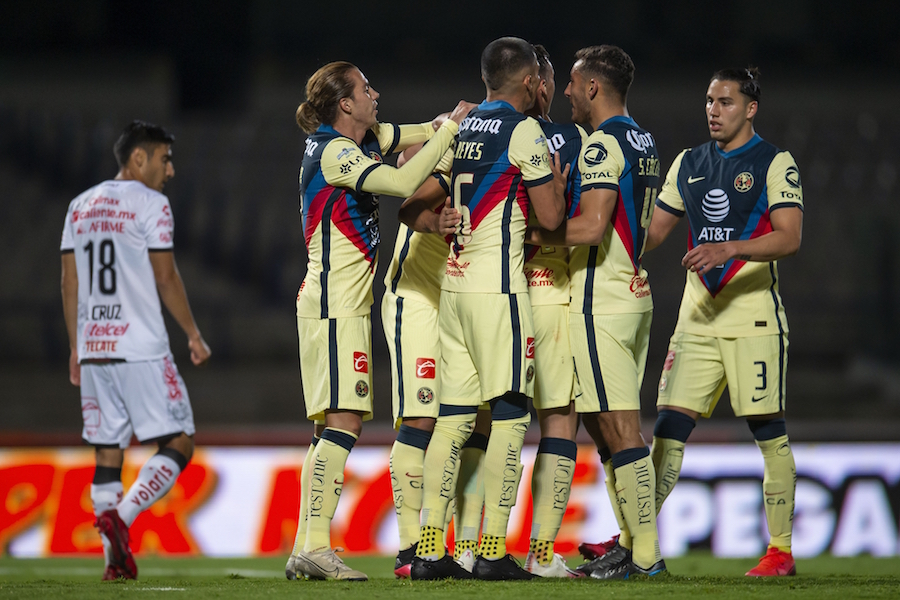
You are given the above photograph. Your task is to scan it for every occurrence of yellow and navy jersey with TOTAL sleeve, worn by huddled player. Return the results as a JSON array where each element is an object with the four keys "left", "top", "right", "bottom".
[{"left": 569, "top": 116, "right": 659, "bottom": 314}]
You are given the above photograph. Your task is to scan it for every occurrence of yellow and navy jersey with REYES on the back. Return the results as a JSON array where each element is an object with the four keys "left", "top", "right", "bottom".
[{"left": 442, "top": 101, "right": 553, "bottom": 294}]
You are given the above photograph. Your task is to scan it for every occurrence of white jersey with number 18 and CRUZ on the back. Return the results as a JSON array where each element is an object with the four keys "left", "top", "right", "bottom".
[{"left": 60, "top": 180, "right": 174, "bottom": 361}]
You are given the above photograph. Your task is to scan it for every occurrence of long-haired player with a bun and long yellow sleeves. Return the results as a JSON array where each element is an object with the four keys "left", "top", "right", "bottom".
[{"left": 285, "top": 62, "right": 472, "bottom": 580}]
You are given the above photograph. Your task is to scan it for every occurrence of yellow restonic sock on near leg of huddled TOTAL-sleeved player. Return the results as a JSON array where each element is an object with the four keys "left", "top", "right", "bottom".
[{"left": 612, "top": 446, "right": 662, "bottom": 569}]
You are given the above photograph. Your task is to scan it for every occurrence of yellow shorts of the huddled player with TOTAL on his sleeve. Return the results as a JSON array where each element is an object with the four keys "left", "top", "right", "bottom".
[{"left": 569, "top": 311, "right": 653, "bottom": 413}]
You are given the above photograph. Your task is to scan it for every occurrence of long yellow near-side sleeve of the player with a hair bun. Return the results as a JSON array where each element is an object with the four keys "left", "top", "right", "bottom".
[{"left": 320, "top": 119, "right": 459, "bottom": 198}]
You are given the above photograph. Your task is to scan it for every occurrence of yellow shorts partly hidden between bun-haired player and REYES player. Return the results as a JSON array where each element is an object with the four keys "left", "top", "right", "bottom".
[{"left": 381, "top": 291, "right": 441, "bottom": 429}]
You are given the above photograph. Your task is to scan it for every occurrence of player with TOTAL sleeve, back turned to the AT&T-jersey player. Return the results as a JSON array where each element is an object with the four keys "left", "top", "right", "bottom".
[{"left": 529, "top": 46, "right": 666, "bottom": 579}]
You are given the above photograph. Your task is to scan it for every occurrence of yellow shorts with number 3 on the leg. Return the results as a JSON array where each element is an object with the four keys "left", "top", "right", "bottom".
[{"left": 656, "top": 332, "right": 788, "bottom": 417}]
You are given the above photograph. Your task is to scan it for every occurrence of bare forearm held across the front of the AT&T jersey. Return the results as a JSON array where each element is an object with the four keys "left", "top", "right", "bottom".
[{"left": 684, "top": 207, "right": 803, "bottom": 275}]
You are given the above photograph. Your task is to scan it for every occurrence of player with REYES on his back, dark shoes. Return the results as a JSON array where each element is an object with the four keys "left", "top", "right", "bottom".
[{"left": 411, "top": 38, "right": 565, "bottom": 579}]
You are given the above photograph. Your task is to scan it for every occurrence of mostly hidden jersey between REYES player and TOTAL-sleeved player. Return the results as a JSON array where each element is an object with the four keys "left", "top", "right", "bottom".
[{"left": 525, "top": 119, "right": 587, "bottom": 306}]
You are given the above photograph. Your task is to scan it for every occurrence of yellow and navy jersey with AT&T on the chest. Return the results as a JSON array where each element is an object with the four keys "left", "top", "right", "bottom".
[{"left": 656, "top": 135, "right": 803, "bottom": 337}]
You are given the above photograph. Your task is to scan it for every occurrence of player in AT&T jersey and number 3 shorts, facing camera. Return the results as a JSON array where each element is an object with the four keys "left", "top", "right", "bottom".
[{"left": 647, "top": 69, "right": 803, "bottom": 577}]
